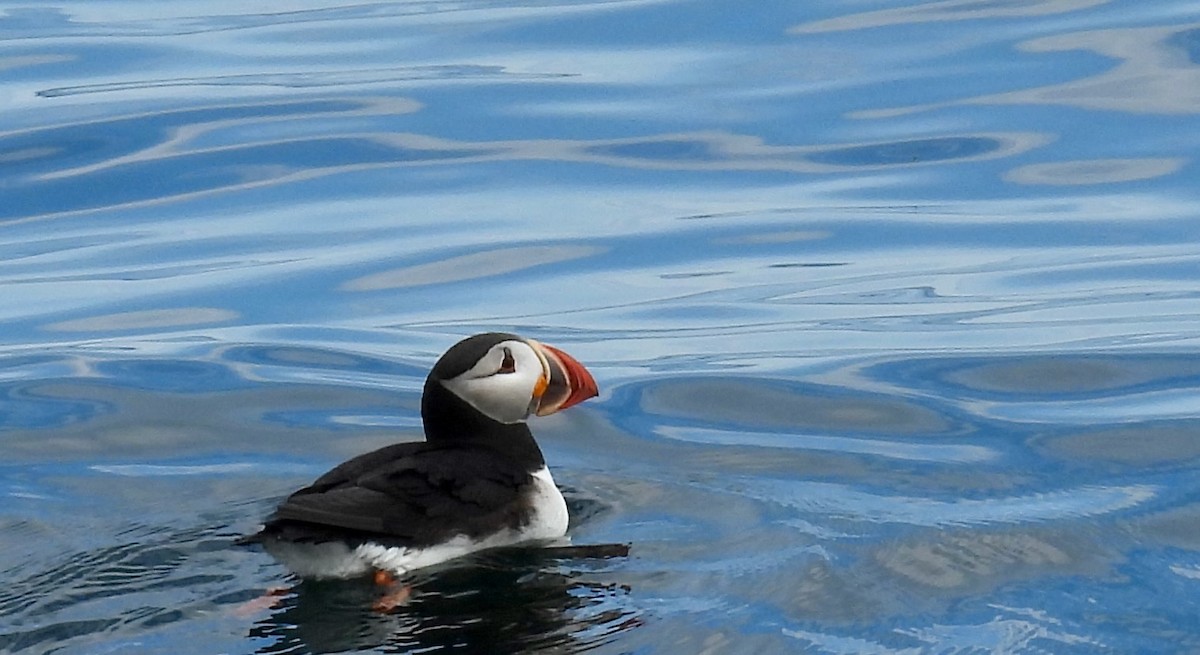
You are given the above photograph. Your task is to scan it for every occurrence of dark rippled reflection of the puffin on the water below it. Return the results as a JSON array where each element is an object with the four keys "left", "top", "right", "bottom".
[{"left": 250, "top": 546, "right": 642, "bottom": 654}]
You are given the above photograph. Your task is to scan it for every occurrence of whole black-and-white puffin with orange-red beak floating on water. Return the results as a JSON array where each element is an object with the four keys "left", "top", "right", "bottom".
[{"left": 245, "top": 332, "right": 598, "bottom": 579}]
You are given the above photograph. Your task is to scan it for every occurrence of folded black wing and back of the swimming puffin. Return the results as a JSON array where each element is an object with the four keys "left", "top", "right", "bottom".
[{"left": 263, "top": 443, "right": 532, "bottom": 546}]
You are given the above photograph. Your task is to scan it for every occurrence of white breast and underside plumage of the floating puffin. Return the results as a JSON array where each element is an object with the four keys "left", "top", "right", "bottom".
[{"left": 263, "top": 467, "right": 569, "bottom": 578}]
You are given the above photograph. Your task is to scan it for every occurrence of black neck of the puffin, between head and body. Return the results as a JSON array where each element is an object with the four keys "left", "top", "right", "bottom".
[{"left": 421, "top": 377, "right": 546, "bottom": 471}]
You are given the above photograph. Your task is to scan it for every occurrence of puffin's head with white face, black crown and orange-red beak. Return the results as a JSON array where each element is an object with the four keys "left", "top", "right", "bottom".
[{"left": 430, "top": 332, "right": 599, "bottom": 423}]
